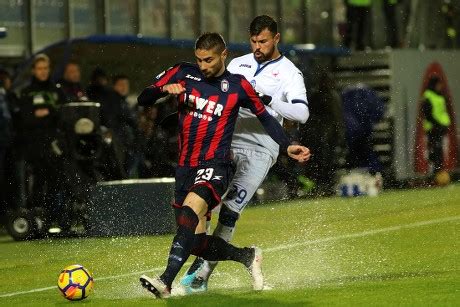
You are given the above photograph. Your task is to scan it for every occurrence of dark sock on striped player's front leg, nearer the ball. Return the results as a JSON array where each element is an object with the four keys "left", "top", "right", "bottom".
[{"left": 160, "top": 206, "right": 198, "bottom": 289}]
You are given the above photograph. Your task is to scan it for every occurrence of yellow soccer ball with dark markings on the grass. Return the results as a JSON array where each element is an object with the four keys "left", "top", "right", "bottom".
[{"left": 58, "top": 264, "right": 94, "bottom": 301}]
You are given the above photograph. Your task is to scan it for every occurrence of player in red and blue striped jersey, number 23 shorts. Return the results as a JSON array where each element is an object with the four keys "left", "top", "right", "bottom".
[{"left": 138, "top": 33, "right": 310, "bottom": 298}]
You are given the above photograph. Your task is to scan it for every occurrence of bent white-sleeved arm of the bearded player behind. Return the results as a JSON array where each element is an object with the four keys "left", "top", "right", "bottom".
[{"left": 262, "top": 71, "right": 310, "bottom": 124}]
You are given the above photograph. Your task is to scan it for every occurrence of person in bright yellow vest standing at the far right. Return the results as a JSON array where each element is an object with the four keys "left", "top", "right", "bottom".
[{"left": 422, "top": 77, "right": 451, "bottom": 173}]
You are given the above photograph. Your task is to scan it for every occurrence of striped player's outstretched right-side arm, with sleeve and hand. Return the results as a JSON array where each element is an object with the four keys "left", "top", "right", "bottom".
[{"left": 241, "top": 78, "right": 310, "bottom": 162}]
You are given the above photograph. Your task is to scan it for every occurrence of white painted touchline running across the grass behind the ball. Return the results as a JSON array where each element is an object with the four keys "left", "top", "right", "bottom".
[{"left": 0, "top": 216, "right": 460, "bottom": 298}]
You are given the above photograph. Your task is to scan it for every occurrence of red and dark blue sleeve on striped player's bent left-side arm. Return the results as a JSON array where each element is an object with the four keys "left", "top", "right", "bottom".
[{"left": 137, "top": 64, "right": 181, "bottom": 106}]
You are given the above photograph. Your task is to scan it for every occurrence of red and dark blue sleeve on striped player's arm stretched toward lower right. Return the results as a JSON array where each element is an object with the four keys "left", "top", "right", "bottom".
[{"left": 241, "top": 78, "right": 290, "bottom": 154}]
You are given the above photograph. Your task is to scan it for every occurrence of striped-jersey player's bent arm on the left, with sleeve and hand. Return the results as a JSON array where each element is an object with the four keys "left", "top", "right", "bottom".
[{"left": 137, "top": 64, "right": 185, "bottom": 106}]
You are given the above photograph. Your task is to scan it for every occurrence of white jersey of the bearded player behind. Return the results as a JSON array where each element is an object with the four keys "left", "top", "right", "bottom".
[{"left": 227, "top": 53, "right": 309, "bottom": 160}]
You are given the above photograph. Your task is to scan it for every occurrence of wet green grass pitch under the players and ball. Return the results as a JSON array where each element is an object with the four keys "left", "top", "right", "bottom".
[{"left": 0, "top": 185, "right": 460, "bottom": 306}]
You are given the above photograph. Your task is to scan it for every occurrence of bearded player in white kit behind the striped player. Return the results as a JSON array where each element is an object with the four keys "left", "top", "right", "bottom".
[{"left": 181, "top": 15, "right": 309, "bottom": 293}]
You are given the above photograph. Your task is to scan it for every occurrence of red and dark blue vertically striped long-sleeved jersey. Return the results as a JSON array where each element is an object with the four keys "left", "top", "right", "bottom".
[{"left": 138, "top": 63, "right": 289, "bottom": 167}]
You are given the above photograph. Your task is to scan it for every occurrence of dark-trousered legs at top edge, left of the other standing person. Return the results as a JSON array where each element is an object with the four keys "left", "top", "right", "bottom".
[{"left": 343, "top": 0, "right": 372, "bottom": 50}]
